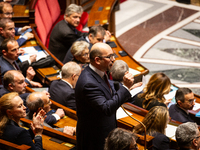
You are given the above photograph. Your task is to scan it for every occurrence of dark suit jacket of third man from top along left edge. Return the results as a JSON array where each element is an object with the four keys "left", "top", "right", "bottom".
[{"left": 0, "top": 56, "right": 29, "bottom": 81}]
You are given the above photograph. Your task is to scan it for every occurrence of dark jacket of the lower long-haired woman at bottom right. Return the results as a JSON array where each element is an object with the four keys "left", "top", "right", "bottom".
[{"left": 152, "top": 132, "right": 170, "bottom": 150}]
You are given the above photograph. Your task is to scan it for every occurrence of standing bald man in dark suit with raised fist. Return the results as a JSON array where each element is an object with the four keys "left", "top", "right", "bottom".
[{"left": 75, "top": 43, "right": 133, "bottom": 150}]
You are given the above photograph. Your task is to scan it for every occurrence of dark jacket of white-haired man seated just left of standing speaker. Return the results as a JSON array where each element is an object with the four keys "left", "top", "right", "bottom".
[{"left": 49, "top": 80, "right": 76, "bottom": 110}]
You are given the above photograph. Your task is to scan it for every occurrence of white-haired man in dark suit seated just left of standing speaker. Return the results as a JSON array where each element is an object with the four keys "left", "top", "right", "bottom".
[{"left": 49, "top": 62, "right": 81, "bottom": 110}]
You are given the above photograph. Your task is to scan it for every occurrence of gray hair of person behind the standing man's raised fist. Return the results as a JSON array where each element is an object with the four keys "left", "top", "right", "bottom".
[{"left": 110, "top": 60, "right": 129, "bottom": 82}]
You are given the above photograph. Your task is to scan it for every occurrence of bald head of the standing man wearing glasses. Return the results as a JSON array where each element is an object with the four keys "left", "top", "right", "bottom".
[{"left": 90, "top": 43, "right": 115, "bottom": 71}]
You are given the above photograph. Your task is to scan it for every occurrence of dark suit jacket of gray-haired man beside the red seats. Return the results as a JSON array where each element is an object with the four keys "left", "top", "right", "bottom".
[{"left": 49, "top": 20, "right": 86, "bottom": 62}]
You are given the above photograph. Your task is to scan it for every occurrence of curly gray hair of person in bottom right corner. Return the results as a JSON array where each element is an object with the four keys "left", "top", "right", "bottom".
[{"left": 175, "top": 122, "right": 199, "bottom": 147}]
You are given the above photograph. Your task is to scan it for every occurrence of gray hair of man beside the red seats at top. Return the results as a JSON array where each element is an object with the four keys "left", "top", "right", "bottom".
[{"left": 65, "top": 4, "right": 83, "bottom": 16}]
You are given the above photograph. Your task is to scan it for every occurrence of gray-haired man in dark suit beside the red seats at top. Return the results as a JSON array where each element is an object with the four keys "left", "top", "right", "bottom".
[{"left": 49, "top": 4, "right": 86, "bottom": 62}]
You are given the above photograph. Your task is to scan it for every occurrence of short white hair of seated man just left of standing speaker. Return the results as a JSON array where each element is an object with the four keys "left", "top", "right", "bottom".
[{"left": 61, "top": 61, "right": 81, "bottom": 78}]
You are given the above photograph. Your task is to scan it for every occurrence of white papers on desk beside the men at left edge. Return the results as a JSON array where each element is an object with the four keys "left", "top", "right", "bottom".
[{"left": 19, "top": 46, "right": 47, "bottom": 62}]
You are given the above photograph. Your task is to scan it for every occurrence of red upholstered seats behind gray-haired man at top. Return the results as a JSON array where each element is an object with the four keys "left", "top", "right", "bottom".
[{"left": 35, "top": 0, "right": 89, "bottom": 48}]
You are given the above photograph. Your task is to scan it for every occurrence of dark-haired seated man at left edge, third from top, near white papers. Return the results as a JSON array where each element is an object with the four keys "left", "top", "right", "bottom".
[{"left": 0, "top": 39, "right": 42, "bottom": 87}]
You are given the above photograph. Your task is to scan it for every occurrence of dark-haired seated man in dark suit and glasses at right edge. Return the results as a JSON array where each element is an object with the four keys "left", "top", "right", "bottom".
[{"left": 169, "top": 88, "right": 195, "bottom": 123}]
